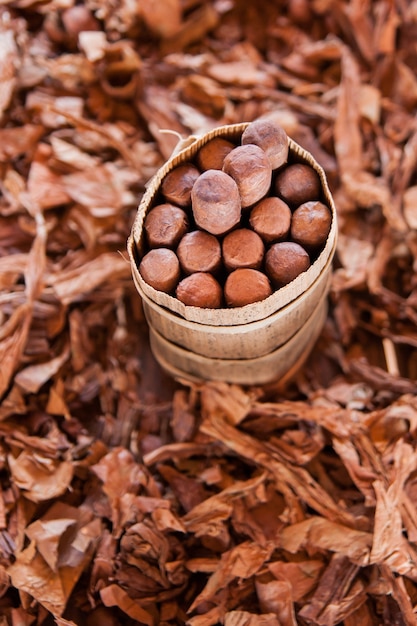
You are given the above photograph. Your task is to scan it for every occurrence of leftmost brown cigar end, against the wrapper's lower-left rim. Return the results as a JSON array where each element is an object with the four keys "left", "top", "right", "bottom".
[{"left": 139, "top": 248, "right": 180, "bottom": 293}]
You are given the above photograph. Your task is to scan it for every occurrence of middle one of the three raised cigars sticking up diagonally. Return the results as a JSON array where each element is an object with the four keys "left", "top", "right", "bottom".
[{"left": 223, "top": 144, "right": 272, "bottom": 208}]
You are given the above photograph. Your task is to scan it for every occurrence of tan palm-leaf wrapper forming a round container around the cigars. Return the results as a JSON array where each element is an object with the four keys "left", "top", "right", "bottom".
[{"left": 128, "top": 123, "right": 337, "bottom": 385}]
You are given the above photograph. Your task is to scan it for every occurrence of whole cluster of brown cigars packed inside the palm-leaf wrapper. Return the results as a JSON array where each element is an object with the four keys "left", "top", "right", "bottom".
[{"left": 139, "top": 119, "right": 332, "bottom": 308}]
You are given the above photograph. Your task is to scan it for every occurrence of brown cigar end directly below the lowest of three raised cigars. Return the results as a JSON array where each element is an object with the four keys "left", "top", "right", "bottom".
[{"left": 177, "top": 230, "right": 222, "bottom": 274}]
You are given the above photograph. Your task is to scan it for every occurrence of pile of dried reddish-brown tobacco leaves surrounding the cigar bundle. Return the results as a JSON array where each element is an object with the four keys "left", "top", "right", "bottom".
[{"left": 0, "top": 0, "right": 417, "bottom": 626}]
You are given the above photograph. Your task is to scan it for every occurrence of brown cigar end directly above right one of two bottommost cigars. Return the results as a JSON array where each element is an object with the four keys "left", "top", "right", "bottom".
[{"left": 222, "top": 228, "right": 265, "bottom": 271}]
